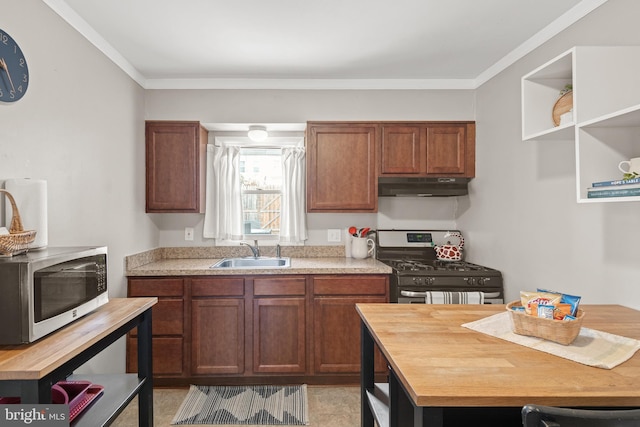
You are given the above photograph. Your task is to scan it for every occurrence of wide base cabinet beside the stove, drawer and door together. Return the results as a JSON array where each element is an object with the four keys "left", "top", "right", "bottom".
[{"left": 313, "top": 276, "right": 389, "bottom": 374}]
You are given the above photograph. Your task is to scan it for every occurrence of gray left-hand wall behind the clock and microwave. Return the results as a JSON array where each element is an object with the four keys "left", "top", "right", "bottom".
[{"left": 0, "top": 0, "right": 158, "bottom": 371}]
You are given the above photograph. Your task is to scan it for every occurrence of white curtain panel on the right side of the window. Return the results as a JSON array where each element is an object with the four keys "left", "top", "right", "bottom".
[{"left": 280, "top": 147, "right": 307, "bottom": 243}]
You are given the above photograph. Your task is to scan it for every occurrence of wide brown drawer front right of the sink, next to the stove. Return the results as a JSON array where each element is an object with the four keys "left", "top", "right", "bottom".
[{"left": 313, "top": 275, "right": 388, "bottom": 295}]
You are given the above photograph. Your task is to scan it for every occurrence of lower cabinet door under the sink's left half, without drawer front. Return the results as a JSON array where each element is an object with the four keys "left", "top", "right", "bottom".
[{"left": 191, "top": 298, "right": 245, "bottom": 375}]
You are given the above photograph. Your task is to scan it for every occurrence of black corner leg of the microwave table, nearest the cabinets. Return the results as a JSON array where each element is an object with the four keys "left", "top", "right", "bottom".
[{"left": 138, "top": 309, "right": 153, "bottom": 427}]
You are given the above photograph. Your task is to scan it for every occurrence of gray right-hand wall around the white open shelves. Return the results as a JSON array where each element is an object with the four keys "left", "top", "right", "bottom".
[{"left": 458, "top": 0, "right": 640, "bottom": 308}]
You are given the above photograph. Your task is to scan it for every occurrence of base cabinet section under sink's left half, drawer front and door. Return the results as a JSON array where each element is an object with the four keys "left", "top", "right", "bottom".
[{"left": 190, "top": 278, "right": 246, "bottom": 375}]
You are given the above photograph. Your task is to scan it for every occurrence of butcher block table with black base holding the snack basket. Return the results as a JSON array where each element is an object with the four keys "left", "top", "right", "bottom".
[{"left": 356, "top": 304, "right": 640, "bottom": 427}]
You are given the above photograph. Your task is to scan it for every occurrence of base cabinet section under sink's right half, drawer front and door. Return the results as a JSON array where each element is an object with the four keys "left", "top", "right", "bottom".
[{"left": 253, "top": 277, "right": 307, "bottom": 374}]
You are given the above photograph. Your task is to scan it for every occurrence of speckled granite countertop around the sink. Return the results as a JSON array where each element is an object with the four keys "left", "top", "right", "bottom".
[{"left": 125, "top": 246, "right": 391, "bottom": 277}]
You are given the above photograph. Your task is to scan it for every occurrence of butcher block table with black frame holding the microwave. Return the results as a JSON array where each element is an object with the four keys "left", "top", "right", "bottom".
[{"left": 0, "top": 298, "right": 157, "bottom": 427}]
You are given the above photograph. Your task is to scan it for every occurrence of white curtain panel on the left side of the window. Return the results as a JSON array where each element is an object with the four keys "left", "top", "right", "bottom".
[{"left": 202, "top": 144, "right": 243, "bottom": 240}]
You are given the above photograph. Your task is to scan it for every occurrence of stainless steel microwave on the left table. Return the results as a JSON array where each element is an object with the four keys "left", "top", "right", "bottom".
[{"left": 0, "top": 246, "right": 109, "bottom": 345}]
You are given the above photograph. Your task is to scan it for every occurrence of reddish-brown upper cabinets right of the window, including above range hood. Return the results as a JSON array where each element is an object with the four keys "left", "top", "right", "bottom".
[{"left": 307, "top": 122, "right": 476, "bottom": 212}]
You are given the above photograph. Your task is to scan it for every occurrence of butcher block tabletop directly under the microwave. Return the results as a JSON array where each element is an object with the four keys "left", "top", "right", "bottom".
[{"left": 0, "top": 297, "right": 158, "bottom": 381}]
